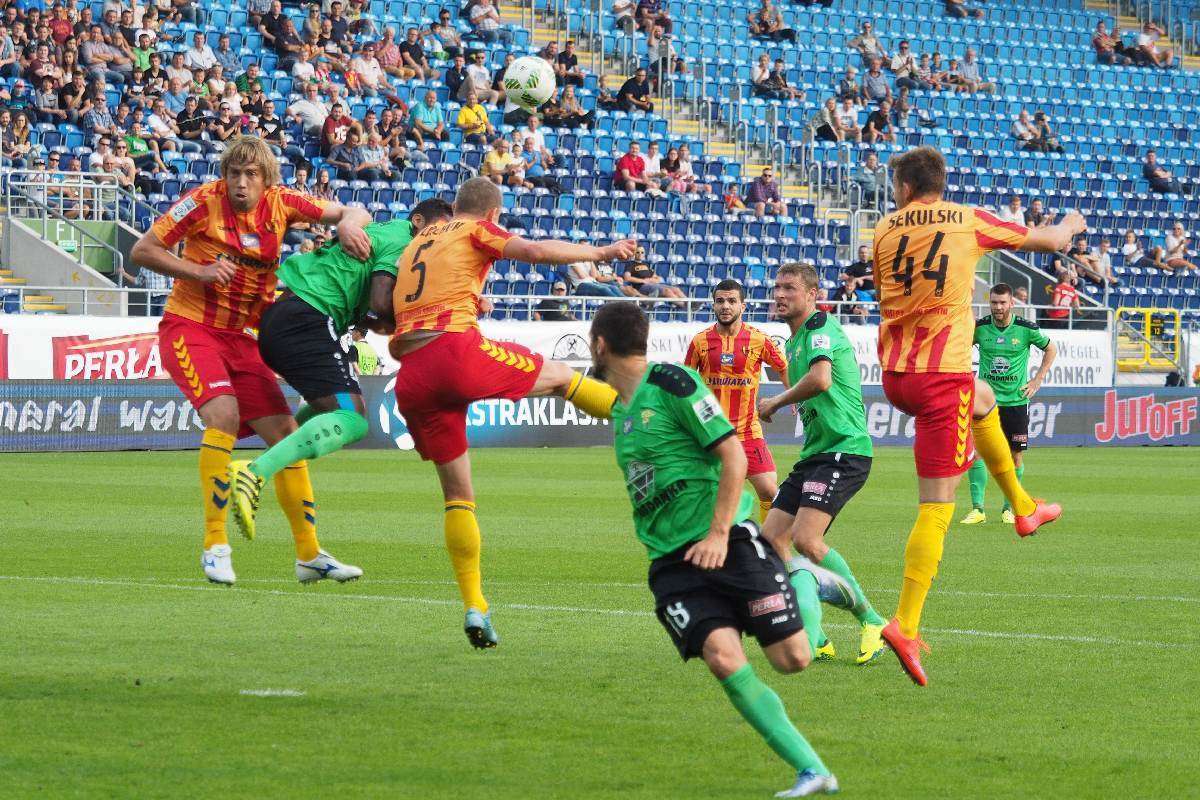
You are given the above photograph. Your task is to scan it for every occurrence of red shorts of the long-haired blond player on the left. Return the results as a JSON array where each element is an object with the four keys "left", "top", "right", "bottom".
[{"left": 158, "top": 314, "right": 292, "bottom": 437}]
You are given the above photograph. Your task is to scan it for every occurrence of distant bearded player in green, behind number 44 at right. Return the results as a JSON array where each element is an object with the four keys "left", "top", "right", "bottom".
[{"left": 960, "top": 283, "right": 1058, "bottom": 525}]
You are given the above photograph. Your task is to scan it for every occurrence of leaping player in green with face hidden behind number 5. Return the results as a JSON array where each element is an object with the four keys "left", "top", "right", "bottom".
[{"left": 229, "top": 198, "right": 452, "bottom": 539}]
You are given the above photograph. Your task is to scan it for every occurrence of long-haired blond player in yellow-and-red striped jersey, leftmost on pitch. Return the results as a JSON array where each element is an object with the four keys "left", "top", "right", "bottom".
[{"left": 130, "top": 137, "right": 371, "bottom": 584}]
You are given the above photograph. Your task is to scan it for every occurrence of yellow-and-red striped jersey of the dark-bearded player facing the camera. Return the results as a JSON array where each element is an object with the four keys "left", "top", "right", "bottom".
[{"left": 684, "top": 323, "right": 787, "bottom": 441}]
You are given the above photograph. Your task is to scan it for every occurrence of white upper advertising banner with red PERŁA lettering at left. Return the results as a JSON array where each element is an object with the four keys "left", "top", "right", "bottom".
[{"left": 0, "top": 314, "right": 1112, "bottom": 389}]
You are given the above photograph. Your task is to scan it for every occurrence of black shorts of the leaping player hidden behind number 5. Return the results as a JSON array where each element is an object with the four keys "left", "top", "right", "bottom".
[{"left": 258, "top": 294, "right": 362, "bottom": 403}]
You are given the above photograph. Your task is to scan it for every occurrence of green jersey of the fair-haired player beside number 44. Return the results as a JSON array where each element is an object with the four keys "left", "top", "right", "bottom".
[{"left": 785, "top": 311, "right": 875, "bottom": 461}]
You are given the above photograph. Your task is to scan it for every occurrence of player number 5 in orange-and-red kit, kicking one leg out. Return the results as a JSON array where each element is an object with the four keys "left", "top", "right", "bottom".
[{"left": 389, "top": 178, "right": 636, "bottom": 648}]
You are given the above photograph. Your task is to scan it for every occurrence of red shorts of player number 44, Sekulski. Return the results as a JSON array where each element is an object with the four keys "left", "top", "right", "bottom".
[{"left": 883, "top": 372, "right": 974, "bottom": 477}]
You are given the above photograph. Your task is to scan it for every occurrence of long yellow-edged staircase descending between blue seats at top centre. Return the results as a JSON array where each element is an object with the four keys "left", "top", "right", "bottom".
[{"left": 500, "top": 2, "right": 810, "bottom": 200}]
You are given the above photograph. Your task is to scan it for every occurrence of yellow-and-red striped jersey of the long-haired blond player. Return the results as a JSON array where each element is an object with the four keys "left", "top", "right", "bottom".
[{"left": 150, "top": 180, "right": 328, "bottom": 331}]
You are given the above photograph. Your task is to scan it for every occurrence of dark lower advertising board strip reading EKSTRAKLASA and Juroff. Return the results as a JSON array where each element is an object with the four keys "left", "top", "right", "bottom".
[{"left": 0, "top": 375, "right": 1200, "bottom": 450}]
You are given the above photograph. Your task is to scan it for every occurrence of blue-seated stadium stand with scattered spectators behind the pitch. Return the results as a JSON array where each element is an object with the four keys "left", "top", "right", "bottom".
[{"left": 0, "top": 0, "right": 1200, "bottom": 328}]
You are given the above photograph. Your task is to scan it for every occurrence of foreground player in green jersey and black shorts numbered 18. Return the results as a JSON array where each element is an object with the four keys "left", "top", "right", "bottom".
[{"left": 592, "top": 302, "right": 838, "bottom": 798}]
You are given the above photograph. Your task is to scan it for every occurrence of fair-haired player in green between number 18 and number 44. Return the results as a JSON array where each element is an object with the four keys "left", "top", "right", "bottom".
[{"left": 758, "top": 264, "right": 886, "bottom": 664}]
